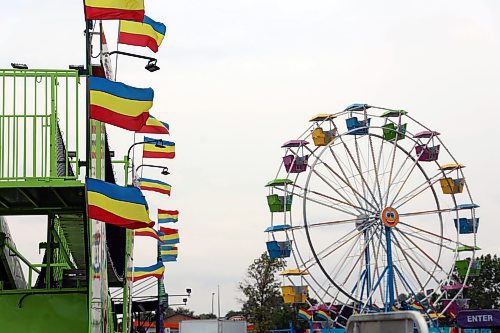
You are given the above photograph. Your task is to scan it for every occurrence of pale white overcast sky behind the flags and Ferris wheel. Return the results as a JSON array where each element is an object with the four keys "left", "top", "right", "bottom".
[{"left": 0, "top": 0, "right": 500, "bottom": 313}]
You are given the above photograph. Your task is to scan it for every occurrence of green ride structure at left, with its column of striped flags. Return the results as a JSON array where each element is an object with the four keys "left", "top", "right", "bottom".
[{"left": 0, "top": 0, "right": 182, "bottom": 333}]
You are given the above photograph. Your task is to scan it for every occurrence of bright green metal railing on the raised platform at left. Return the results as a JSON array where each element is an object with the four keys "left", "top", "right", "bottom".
[{"left": 0, "top": 69, "right": 85, "bottom": 181}]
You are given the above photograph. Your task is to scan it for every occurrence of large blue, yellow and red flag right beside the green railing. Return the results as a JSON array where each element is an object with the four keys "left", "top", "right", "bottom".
[{"left": 89, "top": 76, "right": 154, "bottom": 131}]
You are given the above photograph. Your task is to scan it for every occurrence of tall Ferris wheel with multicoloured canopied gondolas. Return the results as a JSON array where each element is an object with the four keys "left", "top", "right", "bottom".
[{"left": 265, "top": 104, "right": 480, "bottom": 321}]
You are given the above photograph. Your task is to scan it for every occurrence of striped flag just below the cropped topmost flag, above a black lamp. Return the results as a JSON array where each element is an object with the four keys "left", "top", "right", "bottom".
[{"left": 118, "top": 16, "right": 167, "bottom": 52}]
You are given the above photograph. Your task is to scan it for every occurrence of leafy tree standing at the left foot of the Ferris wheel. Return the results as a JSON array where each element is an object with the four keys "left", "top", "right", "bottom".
[{"left": 239, "top": 252, "right": 290, "bottom": 333}]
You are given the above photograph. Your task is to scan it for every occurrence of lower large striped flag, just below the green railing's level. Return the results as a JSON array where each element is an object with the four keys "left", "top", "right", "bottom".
[{"left": 86, "top": 178, "right": 154, "bottom": 229}]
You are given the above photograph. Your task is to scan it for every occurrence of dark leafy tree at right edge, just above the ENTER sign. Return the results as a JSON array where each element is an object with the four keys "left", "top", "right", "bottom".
[{"left": 466, "top": 254, "right": 500, "bottom": 309}]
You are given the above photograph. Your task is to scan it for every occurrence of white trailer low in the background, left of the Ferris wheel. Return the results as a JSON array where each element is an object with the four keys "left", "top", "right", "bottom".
[{"left": 179, "top": 319, "right": 247, "bottom": 333}]
